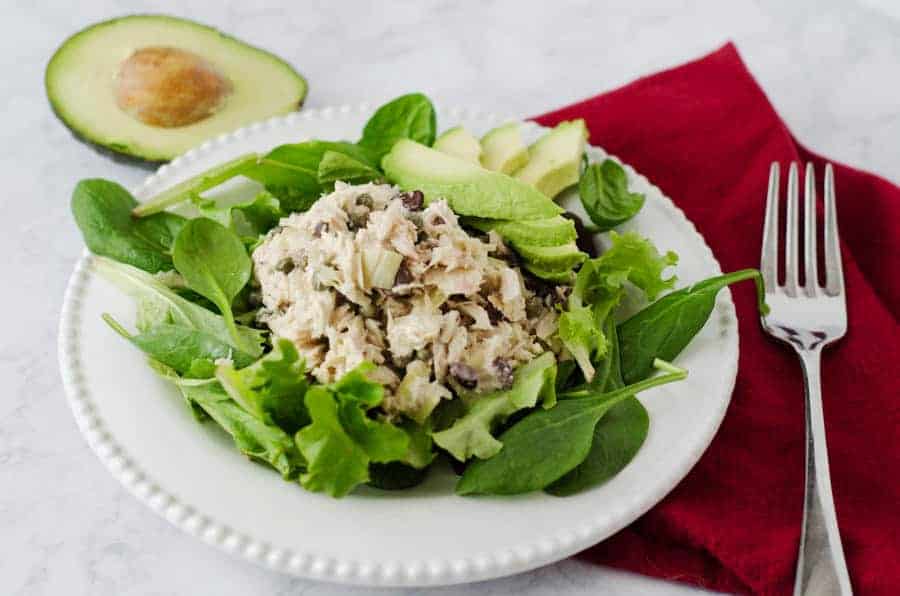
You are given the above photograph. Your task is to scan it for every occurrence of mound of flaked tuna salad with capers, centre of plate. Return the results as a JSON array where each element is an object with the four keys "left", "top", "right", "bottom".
[{"left": 252, "top": 183, "right": 567, "bottom": 421}]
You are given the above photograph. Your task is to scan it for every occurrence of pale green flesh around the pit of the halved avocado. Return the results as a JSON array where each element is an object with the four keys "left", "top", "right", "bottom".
[{"left": 45, "top": 15, "right": 307, "bottom": 162}]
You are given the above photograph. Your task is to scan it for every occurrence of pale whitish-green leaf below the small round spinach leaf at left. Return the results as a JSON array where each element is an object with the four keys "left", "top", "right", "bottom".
[{"left": 93, "top": 257, "right": 264, "bottom": 358}]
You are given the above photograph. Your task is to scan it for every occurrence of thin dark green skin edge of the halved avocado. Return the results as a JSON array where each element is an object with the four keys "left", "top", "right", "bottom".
[{"left": 44, "top": 13, "right": 309, "bottom": 165}]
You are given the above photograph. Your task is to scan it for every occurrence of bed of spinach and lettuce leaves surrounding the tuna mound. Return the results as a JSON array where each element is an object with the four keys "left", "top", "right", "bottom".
[{"left": 72, "top": 94, "right": 764, "bottom": 497}]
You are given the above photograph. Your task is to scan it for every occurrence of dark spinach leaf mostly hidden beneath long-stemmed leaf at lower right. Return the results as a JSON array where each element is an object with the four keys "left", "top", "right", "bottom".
[{"left": 546, "top": 318, "right": 650, "bottom": 497}]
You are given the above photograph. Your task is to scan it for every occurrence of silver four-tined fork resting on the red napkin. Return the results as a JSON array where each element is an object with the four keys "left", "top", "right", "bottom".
[{"left": 760, "top": 162, "right": 852, "bottom": 596}]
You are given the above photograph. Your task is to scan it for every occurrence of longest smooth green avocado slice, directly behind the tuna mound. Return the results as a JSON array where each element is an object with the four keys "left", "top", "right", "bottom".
[{"left": 381, "top": 139, "right": 562, "bottom": 221}]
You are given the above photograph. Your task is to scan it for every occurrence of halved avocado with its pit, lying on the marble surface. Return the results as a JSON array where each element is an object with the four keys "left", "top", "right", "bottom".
[{"left": 44, "top": 15, "right": 307, "bottom": 162}]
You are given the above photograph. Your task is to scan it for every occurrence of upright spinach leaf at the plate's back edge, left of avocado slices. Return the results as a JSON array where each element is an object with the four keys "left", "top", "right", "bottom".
[{"left": 359, "top": 93, "right": 437, "bottom": 161}]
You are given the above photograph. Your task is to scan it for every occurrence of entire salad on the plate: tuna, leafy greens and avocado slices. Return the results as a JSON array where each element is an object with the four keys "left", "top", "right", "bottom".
[{"left": 72, "top": 93, "right": 760, "bottom": 496}]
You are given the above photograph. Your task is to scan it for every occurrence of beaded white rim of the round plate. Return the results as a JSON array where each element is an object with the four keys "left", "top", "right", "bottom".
[{"left": 57, "top": 103, "right": 740, "bottom": 587}]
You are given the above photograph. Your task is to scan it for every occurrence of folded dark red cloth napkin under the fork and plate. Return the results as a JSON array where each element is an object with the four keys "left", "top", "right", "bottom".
[{"left": 535, "top": 44, "right": 900, "bottom": 594}]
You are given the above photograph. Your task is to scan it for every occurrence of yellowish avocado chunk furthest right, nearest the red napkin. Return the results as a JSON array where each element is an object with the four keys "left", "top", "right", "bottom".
[{"left": 515, "top": 119, "right": 588, "bottom": 198}]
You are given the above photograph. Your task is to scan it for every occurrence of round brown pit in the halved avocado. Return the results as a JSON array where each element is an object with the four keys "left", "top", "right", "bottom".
[{"left": 115, "top": 46, "right": 232, "bottom": 128}]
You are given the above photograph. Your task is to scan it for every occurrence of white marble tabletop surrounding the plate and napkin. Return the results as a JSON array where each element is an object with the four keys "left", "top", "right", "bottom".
[{"left": 0, "top": 0, "right": 900, "bottom": 596}]
